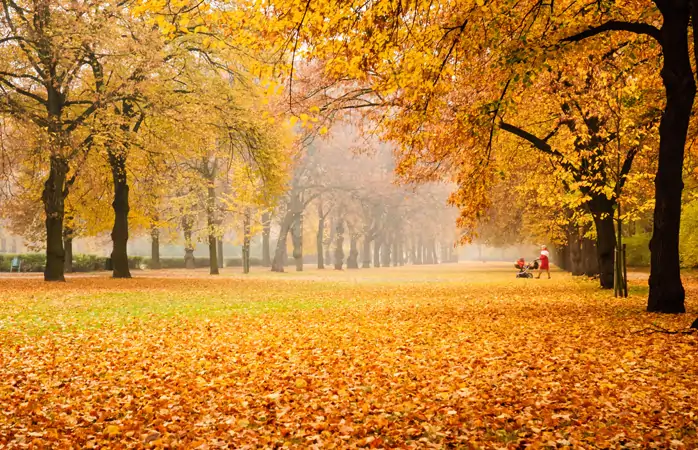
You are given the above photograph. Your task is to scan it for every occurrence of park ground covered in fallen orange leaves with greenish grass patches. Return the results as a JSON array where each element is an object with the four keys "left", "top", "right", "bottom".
[{"left": 0, "top": 264, "right": 698, "bottom": 448}]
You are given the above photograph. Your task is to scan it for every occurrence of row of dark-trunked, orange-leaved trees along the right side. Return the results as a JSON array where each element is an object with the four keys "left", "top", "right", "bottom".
[{"left": 160, "top": 0, "right": 696, "bottom": 312}]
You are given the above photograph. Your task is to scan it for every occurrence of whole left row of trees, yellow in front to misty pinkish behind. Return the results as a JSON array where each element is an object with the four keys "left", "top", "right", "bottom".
[{"left": 0, "top": 0, "right": 454, "bottom": 281}]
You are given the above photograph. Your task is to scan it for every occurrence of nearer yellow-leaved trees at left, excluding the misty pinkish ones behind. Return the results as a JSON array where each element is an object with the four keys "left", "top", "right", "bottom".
[{"left": 0, "top": 0, "right": 294, "bottom": 281}]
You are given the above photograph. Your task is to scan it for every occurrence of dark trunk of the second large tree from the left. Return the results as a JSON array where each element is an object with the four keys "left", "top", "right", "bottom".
[{"left": 108, "top": 150, "right": 131, "bottom": 278}]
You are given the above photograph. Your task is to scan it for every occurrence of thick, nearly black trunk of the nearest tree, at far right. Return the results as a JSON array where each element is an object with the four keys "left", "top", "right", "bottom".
[{"left": 647, "top": 14, "right": 697, "bottom": 313}]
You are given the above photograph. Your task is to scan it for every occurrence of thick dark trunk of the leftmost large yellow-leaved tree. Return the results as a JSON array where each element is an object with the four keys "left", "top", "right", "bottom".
[{"left": 41, "top": 155, "right": 68, "bottom": 281}]
